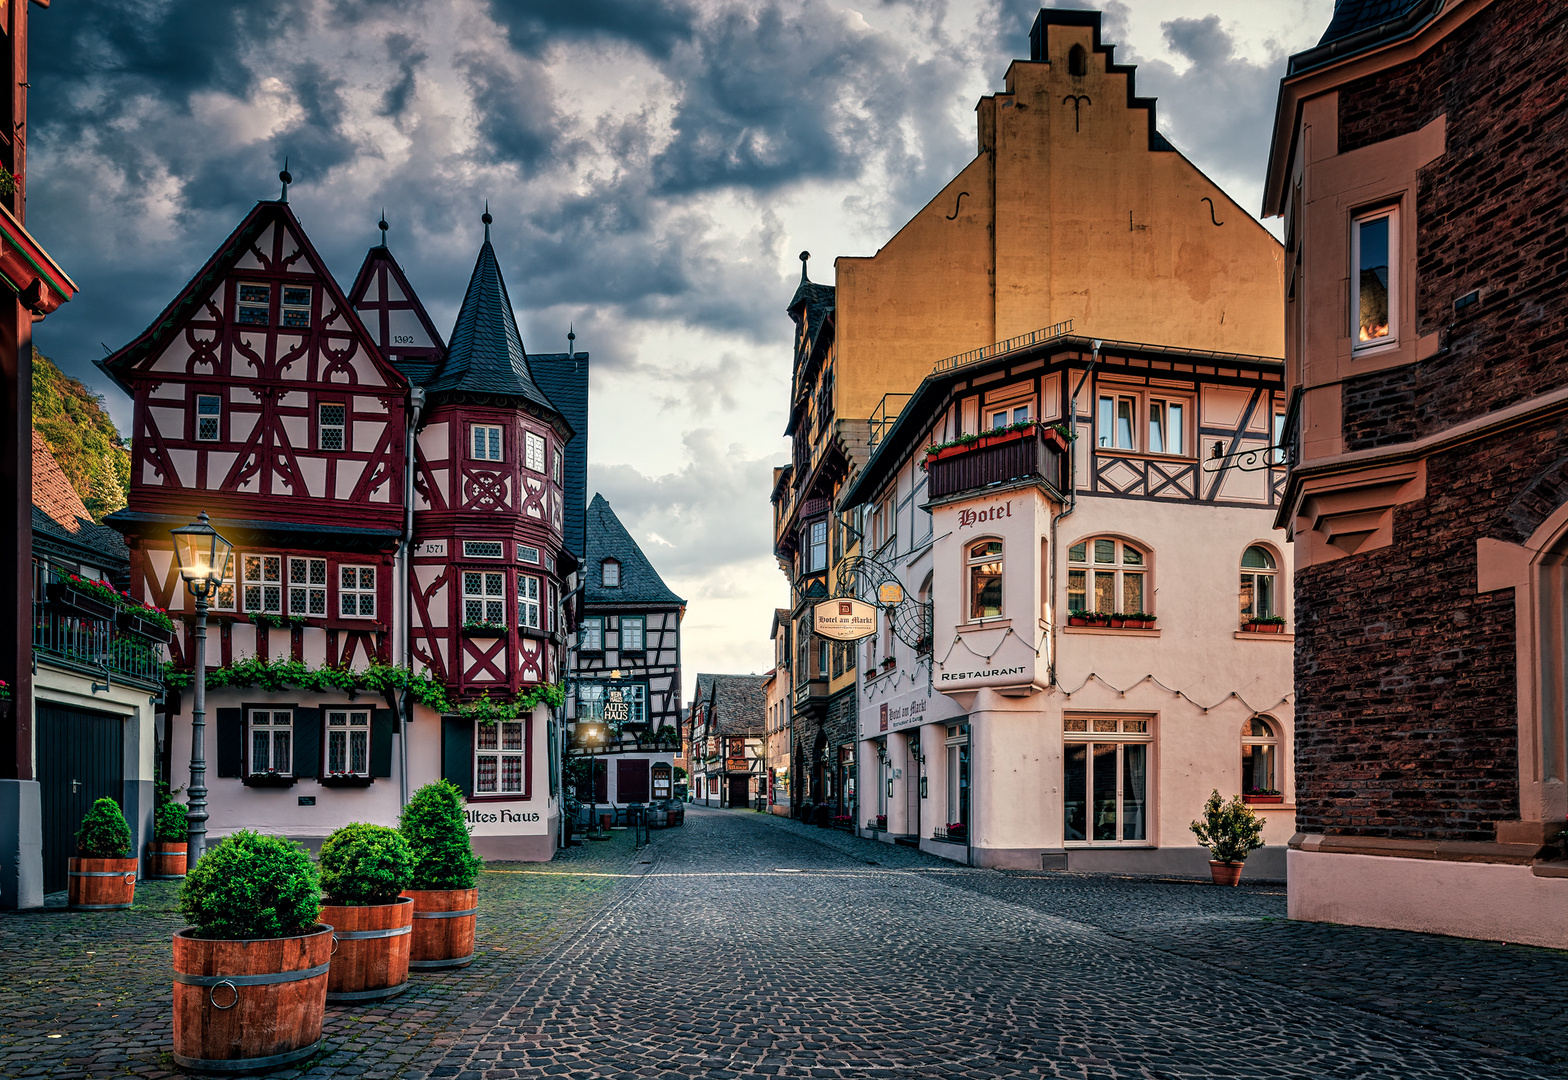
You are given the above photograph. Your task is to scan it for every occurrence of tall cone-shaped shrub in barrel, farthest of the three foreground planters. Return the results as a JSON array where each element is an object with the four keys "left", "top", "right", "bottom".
[{"left": 398, "top": 781, "right": 481, "bottom": 970}]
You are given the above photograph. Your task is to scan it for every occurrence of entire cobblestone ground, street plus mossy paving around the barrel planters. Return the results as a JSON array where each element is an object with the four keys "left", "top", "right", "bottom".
[{"left": 0, "top": 809, "right": 1568, "bottom": 1080}]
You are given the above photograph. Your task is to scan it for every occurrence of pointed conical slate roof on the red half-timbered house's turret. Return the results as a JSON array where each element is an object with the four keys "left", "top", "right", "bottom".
[{"left": 425, "top": 224, "right": 560, "bottom": 414}]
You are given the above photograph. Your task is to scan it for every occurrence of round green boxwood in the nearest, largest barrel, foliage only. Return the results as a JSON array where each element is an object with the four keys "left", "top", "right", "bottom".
[{"left": 180, "top": 832, "right": 321, "bottom": 940}]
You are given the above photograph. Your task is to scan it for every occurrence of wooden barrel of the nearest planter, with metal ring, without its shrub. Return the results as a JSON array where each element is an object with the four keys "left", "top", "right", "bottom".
[{"left": 174, "top": 926, "right": 332, "bottom": 1072}]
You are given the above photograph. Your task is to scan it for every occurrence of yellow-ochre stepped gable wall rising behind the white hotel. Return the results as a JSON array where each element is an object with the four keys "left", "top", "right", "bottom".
[{"left": 836, "top": 25, "right": 1284, "bottom": 417}]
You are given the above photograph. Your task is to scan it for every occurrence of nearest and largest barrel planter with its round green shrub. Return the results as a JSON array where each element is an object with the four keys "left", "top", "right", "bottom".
[{"left": 174, "top": 832, "right": 332, "bottom": 1072}]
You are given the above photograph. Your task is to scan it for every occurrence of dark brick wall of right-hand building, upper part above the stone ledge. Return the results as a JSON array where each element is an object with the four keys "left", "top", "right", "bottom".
[{"left": 1339, "top": 0, "right": 1568, "bottom": 450}]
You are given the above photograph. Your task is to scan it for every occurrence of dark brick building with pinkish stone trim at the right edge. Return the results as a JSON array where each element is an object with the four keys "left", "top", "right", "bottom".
[{"left": 1264, "top": 0, "right": 1568, "bottom": 947}]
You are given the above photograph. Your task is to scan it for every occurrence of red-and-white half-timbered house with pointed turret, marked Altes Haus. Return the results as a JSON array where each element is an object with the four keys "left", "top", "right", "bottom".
[{"left": 102, "top": 199, "right": 574, "bottom": 859}]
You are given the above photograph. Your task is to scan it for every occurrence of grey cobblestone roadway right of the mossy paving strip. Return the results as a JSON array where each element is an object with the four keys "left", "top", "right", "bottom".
[{"left": 434, "top": 809, "right": 1568, "bottom": 1080}]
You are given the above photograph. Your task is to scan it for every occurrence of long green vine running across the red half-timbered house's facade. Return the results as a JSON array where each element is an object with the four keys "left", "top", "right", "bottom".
[{"left": 163, "top": 657, "right": 566, "bottom": 724}]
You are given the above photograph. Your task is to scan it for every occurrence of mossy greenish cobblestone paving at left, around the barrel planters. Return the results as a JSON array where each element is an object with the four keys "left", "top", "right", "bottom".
[{"left": 0, "top": 831, "right": 642, "bottom": 1080}]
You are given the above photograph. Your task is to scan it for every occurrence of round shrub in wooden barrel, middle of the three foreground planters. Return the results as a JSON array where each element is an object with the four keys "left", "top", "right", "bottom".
[{"left": 320, "top": 821, "right": 414, "bottom": 1002}]
